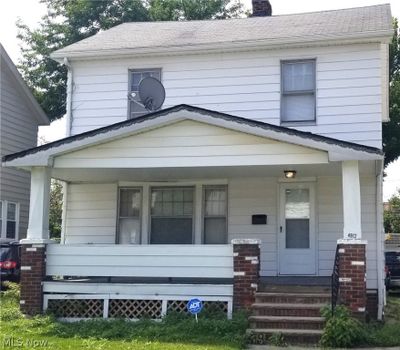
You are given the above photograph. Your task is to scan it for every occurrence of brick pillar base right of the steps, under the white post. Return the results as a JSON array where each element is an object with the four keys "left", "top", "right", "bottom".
[{"left": 338, "top": 240, "right": 367, "bottom": 318}]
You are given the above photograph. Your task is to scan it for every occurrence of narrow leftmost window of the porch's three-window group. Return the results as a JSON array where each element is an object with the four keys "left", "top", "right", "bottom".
[{"left": 117, "top": 188, "right": 142, "bottom": 244}]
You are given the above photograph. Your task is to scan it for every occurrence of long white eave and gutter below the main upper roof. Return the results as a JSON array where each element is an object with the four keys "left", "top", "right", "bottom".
[{"left": 50, "top": 29, "right": 393, "bottom": 63}]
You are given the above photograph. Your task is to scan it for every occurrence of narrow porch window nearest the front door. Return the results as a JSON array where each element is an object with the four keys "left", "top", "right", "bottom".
[{"left": 203, "top": 186, "right": 227, "bottom": 244}]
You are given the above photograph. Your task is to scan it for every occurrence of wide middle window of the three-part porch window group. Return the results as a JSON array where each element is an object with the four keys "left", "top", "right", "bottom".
[{"left": 150, "top": 187, "right": 194, "bottom": 244}]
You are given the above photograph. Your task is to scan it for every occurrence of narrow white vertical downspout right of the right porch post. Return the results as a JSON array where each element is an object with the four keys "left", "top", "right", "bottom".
[{"left": 375, "top": 160, "right": 386, "bottom": 320}]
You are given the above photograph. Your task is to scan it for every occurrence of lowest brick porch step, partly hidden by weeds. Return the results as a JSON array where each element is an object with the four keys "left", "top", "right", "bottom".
[{"left": 247, "top": 328, "right": 322, "bottom": 344}]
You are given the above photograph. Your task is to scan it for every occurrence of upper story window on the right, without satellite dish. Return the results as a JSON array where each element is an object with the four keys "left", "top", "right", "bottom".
[{"left": 281, "top": 60, "right": 316, "bottom": 123}]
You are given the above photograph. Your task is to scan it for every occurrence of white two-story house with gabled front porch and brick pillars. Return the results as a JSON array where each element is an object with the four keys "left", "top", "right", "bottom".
[{"left": 3, "top": 1, "right": 393, "bottom": 342}]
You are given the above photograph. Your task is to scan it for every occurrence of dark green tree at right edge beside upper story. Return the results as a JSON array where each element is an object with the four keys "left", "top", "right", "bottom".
[{"left": 382, "top": 19, "right": 400, "bottom": 166}]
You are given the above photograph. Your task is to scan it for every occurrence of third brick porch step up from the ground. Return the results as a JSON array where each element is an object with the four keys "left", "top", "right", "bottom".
[{"left": 251, "top": 303, "right": 327, "bottom": 317}]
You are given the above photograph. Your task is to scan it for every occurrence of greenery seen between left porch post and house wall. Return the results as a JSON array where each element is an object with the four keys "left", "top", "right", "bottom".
[{"left": 49, "top": 180, "right": 63, "bottom": 239}]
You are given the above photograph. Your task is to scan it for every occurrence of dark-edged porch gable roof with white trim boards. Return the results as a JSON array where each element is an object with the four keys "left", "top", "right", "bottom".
[{"left": 2, "top": 104, "right": 383, "bottom": 167}]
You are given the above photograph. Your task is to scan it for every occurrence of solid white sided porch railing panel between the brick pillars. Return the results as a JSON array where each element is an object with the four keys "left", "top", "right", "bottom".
[{"left": 46, "top": 244, "right": 233, "bottom": 279}]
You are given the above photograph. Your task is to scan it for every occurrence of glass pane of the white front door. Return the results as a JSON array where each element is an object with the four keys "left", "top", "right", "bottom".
[{"left": 285, "top": 188, "right": 310, "bottom": 249}]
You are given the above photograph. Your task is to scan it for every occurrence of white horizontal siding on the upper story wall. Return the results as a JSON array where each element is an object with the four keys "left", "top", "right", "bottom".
[{"left": 72, "top": 44, "right": 382, "bottom": 147}]
